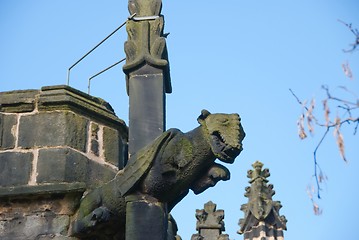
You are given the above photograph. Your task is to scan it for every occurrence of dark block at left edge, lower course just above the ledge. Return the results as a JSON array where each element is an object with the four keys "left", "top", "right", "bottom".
[{"left": 0, "top": 152, "right": 33, "bottom": 187}]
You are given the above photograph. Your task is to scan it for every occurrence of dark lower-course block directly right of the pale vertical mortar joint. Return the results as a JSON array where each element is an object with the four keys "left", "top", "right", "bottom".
[{"left": 37, "top": 148, "right": 88, "bottom": 183}]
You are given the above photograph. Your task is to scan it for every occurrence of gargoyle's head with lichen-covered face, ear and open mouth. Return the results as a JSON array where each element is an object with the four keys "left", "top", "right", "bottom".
[{"left": 197, "top": 110, "right": 245, "bottom": 163}]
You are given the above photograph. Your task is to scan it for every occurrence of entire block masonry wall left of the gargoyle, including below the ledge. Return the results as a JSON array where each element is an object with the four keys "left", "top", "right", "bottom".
[{"left": 0, "top": 86, "right": 128, "bottom": 240}]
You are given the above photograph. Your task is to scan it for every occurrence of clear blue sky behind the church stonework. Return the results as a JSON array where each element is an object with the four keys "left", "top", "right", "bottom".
[{"left": 0, "top": 0, "right": 359, "bottom": 240}]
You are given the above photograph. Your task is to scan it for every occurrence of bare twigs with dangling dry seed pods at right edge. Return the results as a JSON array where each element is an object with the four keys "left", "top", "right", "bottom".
[{"left": 289, "top": 20, "right": 359, "bottom": 215}]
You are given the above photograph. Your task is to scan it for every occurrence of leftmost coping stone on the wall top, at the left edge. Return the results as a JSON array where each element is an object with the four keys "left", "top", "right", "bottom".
[{"left": 0, "top": 90, "right": 39, "bottom": 113}]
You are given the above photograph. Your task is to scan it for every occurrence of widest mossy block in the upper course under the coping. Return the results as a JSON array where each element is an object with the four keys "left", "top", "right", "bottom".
[{"left": 18, "top": 111, "right": 88, "bottom": 152}]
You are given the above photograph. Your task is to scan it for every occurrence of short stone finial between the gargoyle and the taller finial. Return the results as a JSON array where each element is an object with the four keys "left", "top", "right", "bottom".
[{"left": 191, "top": 201, "right": 229, "bottom": 240}]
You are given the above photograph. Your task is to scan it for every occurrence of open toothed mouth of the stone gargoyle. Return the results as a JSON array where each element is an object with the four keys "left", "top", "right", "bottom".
[{"left": 211, "top": 131, "right": 241, "bottom": 163}]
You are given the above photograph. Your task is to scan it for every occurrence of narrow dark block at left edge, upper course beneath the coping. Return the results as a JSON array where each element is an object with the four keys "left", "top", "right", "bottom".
[{"left": 0, "top": 113, "right": 17, "bottom": 149}]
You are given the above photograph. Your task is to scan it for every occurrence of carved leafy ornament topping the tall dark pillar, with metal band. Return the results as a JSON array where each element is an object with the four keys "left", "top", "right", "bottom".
[{"left": 123, "top": 0, "right": 172, "bottom": 93}]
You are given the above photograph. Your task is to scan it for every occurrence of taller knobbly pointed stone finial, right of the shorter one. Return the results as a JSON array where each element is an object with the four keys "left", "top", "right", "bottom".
[{"left": 238, "top": 161, "right": 287, "bottom": 240}]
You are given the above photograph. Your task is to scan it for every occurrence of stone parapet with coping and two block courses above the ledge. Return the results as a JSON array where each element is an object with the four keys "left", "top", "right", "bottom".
[{"left": 0, "top": 86, "right": 127, "bottom": 188}]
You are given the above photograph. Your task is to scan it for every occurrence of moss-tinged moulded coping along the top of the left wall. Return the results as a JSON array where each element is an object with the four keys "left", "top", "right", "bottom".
[{"left": 0, "top": 85, "right": 128, "bottom": 139}]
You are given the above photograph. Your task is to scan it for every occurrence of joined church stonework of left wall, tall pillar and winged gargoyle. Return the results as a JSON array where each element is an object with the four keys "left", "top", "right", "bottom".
[{"left": 0, "top": 0, "right": 250, "bottom": 240}]
